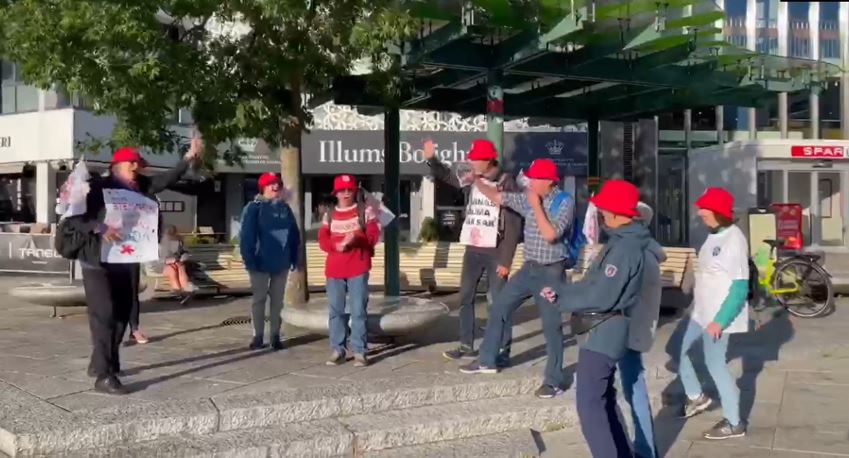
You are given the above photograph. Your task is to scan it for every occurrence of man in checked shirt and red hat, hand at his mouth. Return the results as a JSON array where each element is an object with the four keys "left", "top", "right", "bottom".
[{"left": 460, "top": 159, "right": 575, "bottom": 399}]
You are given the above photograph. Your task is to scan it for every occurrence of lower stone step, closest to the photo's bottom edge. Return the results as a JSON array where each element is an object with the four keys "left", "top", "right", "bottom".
[{"left": 58, "top": 395, "right": 577, "bottom": 458}]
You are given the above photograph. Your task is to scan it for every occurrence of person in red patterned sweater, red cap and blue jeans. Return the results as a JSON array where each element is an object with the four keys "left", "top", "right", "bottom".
[{"left": 318, "top": 174, "right": 380, "bottom": 367}]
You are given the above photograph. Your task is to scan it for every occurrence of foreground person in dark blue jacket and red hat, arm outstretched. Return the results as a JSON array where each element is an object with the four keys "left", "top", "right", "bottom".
[{"left": 538, "top": 180, "right": 654, "bottom": 458}]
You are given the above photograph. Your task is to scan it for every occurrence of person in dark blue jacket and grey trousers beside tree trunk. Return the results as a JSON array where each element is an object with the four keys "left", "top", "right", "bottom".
[{"left": 239, "top": 173, "right": 301, "bottom": 350}]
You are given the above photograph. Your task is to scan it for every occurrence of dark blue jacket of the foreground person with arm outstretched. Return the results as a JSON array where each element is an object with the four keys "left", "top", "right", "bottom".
[{"left": 553, "top": 223, "right": 653, "bottom": 360}]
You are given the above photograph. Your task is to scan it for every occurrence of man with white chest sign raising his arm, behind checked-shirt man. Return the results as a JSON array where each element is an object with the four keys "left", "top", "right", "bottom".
[{"left": 424, "top": 140, "right": 522, "bottom": 366}]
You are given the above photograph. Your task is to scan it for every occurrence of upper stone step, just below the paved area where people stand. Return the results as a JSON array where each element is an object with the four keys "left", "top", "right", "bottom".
[{"left": 0, "top": 368, "right": 540, "bottom": 457}]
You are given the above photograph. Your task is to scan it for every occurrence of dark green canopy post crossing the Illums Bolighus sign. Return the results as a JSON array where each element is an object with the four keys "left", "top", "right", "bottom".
[{"left": 383, "top": 107, "right": 401, "bottom": 297}]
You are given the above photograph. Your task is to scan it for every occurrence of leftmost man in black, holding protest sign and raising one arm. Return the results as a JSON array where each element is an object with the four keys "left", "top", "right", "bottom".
[{"left": 63, "top": 144, "right": 202, "bottom": 394}]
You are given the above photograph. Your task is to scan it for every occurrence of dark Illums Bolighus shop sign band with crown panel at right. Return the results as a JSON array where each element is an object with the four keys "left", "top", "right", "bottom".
[{"left": 301, "top": 130, "right": 587, "bottom": 176}]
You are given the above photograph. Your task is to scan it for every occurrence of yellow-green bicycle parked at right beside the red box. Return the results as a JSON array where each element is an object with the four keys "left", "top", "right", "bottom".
[{"left": 749, "top": 239, "right": 834, "bottom": 318}]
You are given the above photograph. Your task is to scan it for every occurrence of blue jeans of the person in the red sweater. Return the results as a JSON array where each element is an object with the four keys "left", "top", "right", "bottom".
[{"left": 327, "top": 272, "right": 368, "bottom": 355}]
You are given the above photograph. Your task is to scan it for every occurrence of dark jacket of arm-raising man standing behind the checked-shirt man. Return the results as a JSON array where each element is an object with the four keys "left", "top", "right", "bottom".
[{"left": 427, "top": 158, "right": 524, "bottom": 268}]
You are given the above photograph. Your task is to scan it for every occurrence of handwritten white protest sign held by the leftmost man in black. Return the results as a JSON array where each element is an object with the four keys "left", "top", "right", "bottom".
[{"left": 100, "top": 189, "right": 159, "bottom": 264}]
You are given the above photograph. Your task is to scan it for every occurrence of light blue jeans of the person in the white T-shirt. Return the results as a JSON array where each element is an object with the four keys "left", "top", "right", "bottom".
[{"left": 678, "top": 319, "right": 740, "bottom": 426}]
